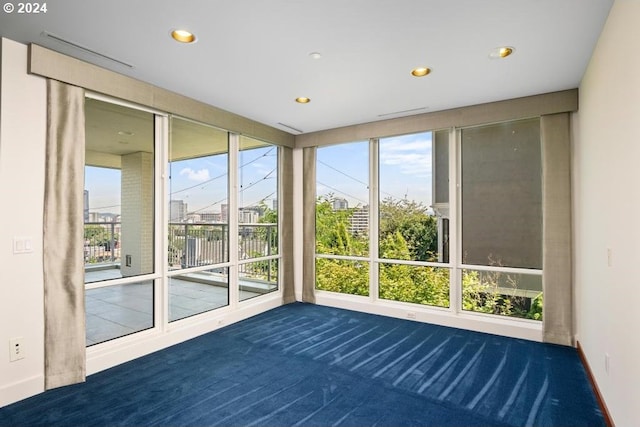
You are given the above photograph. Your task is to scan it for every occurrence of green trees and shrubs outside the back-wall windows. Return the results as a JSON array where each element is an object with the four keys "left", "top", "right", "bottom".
[{"left": 316, "top": 195, "right": 543, "bottom": 320}]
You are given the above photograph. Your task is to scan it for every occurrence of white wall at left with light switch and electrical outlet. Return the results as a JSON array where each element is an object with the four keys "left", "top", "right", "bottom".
[{"left": 0, "top": 39, "right": 47, "bottom": 406}]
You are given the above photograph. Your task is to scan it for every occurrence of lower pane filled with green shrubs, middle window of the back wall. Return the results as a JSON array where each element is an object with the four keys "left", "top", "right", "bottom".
[{"left": 379, "top": 263, "right": 449, "bottom": 307}]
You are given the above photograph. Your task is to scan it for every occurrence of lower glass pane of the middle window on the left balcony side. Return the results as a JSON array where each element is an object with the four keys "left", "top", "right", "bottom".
[{"left": 169, "top": 268, "right": 229, "bottom": 322}]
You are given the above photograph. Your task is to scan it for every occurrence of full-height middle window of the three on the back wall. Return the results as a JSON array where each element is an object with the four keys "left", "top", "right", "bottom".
[{"left": 377, "top": 131, "right": 450, "bottom": 307}]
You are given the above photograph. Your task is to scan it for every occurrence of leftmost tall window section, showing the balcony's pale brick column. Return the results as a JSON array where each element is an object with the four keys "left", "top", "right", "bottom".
[{"left": 84, "top": 98, "right": 156, "bottom": 345}]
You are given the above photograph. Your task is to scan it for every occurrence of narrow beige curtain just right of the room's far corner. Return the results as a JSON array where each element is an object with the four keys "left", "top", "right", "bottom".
[{"left": 302, "top": 147, "right": 316, "bottom": 303}]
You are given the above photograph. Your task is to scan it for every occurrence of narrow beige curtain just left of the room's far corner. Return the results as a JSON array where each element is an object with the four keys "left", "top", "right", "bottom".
[{"left": 280, "top": 147, "right": 296, "bottom": 304}]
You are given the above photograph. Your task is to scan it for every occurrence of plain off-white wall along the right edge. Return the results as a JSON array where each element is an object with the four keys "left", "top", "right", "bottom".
[{"left": 573, "top": 0, "right": 640, "bottom": 426}]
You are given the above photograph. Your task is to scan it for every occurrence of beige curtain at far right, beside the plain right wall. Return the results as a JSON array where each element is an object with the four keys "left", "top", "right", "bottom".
[{"left": 540, "top": 113, "right": 574, "bottom": 345}]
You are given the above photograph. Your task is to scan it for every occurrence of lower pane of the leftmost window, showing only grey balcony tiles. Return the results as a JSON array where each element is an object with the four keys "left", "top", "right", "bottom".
[{"left": 85, "top": 280, "right": 153, "bottom": 346}]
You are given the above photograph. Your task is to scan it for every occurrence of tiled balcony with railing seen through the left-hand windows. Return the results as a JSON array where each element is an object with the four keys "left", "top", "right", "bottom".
[{"left": 84, "top": 222, "right": 278, "bottom": 345}]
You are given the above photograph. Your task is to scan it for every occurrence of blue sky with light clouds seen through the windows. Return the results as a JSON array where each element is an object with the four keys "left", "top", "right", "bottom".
[{"left": 85, "top": 132, "right": 432, "bottom": 214}]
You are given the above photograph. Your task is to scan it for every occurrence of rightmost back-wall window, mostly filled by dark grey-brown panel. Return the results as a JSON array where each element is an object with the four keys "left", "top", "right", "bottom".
[{"left": 460, "top": 119, "right": 542, "bottom": 320}]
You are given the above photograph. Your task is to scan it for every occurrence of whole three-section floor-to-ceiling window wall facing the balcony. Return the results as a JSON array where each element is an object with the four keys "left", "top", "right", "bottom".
[{"left": 84, "top": 95, "right": 281, "bottom": 345}]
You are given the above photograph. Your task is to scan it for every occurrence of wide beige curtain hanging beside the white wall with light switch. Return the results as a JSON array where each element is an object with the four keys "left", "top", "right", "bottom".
[{"left": 43, "top": 80, "right": 86, "bottom": 389}]
